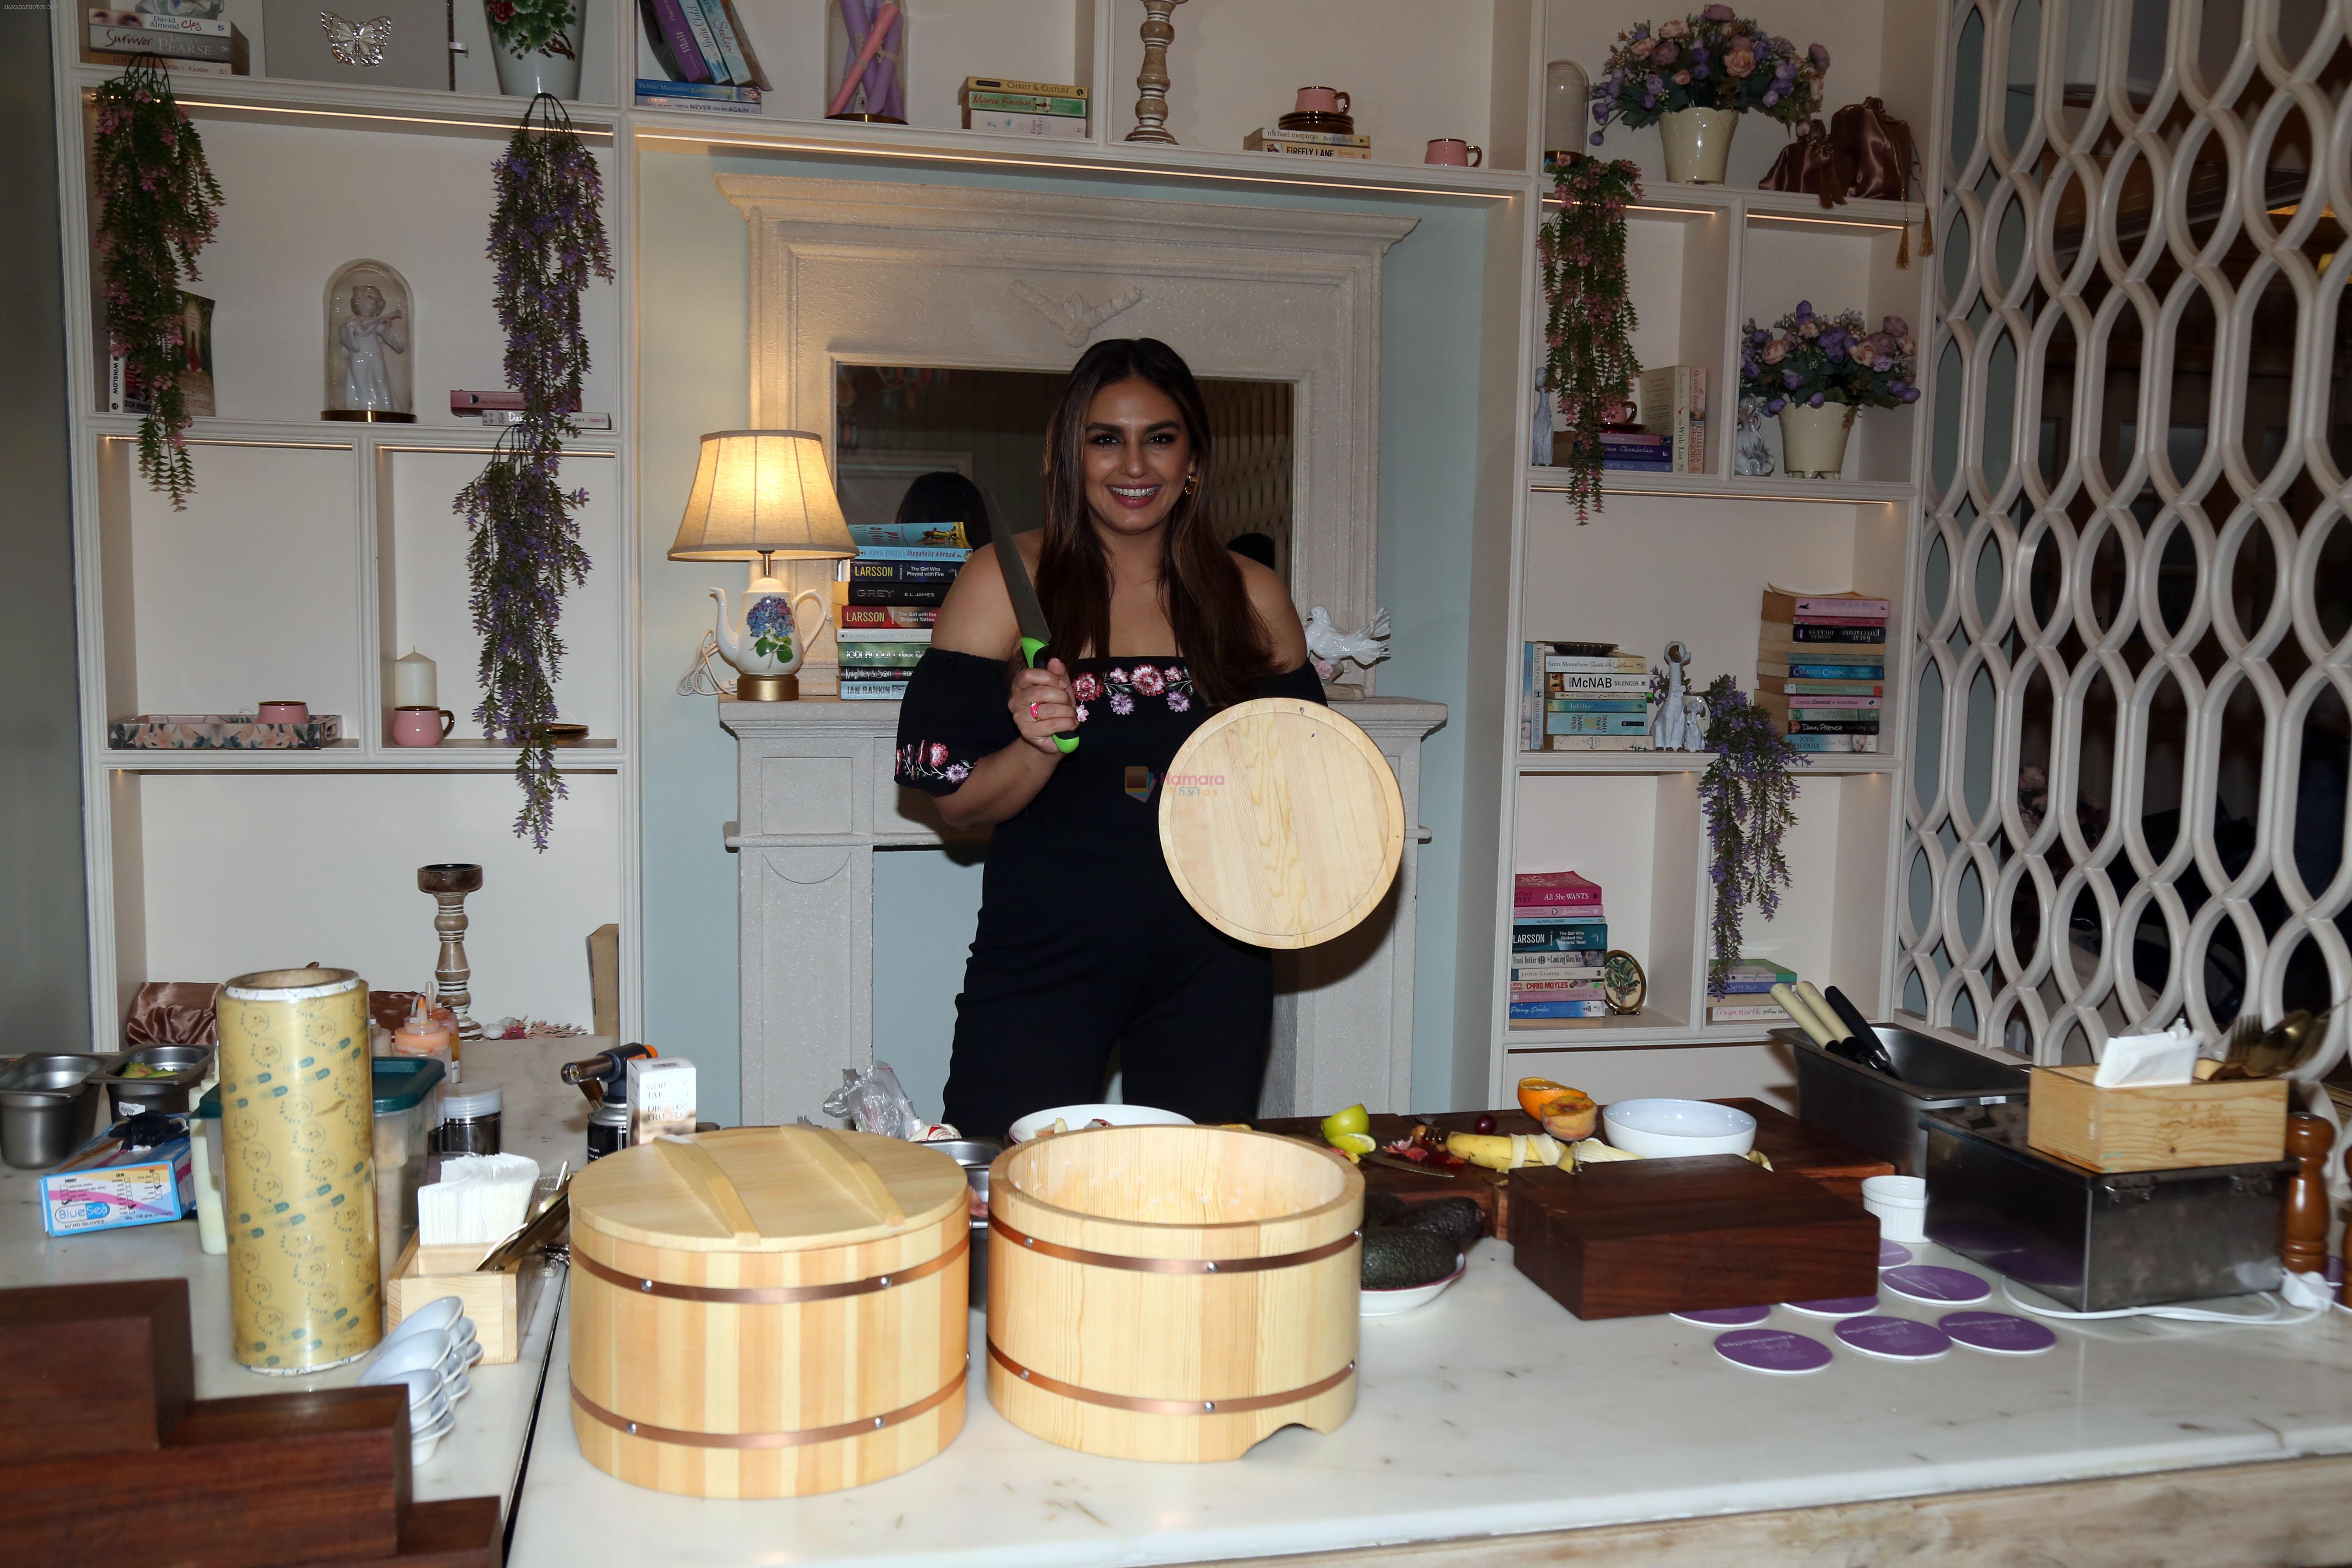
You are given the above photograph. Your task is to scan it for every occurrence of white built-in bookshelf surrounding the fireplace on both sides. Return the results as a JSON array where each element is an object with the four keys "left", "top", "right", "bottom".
[{"left": 54, "top": 0, "right": 1933, "bottom": 1102}]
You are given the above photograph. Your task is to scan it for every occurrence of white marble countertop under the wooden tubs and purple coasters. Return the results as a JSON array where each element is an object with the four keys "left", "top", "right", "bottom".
[{"left": 508, "top": 1241, "right": 2352, "bottom": 1568}]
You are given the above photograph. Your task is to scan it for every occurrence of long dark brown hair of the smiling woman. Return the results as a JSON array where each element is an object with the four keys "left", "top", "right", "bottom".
[{"left": 1037, "top": 339, "right": 1272, "bottom": 707}]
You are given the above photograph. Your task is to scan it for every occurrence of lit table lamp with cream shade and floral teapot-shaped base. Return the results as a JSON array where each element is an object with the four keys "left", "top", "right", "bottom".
[{"left": 671, "top": 430, "right": 858, "bottom": 703}]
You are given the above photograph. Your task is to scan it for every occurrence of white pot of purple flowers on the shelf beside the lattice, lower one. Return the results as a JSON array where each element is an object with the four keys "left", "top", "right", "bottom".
[{"left": 1740, "top": 299, "right": 1919, "bottom": 480}]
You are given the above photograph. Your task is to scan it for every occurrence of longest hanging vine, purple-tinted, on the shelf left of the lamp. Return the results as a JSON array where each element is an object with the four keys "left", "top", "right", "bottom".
[{"left": 456, "top": 94, "right": 612, "bottom": 848}]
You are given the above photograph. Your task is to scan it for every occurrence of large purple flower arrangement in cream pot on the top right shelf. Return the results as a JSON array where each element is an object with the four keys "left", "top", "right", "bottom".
[{"left": 1592, "top": 5, "right": 1830, "bottom": 186}]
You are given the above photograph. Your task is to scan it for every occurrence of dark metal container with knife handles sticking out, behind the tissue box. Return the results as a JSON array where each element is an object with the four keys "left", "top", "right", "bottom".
[{"left": 1771, "top": 1023, "right": 2032, "bottom": 1176}]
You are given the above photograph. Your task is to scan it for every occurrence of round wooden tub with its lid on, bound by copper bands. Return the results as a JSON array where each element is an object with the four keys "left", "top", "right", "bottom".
[{"left": 572, "top": 1126, "right": 964, "bottom": 1498}]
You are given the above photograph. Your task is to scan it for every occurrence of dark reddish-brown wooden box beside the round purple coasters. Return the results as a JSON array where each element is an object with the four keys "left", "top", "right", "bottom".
[{"left": 1510, "top": 1154, "right": 1879, "bottom": 1319}]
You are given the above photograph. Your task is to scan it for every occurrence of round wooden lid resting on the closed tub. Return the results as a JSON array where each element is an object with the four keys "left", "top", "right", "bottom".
[{"left": 572, "top": 1126, "right": 967, "bottom": 1253}]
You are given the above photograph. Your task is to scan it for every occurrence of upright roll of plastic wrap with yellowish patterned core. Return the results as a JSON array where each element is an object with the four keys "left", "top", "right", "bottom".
[{"left": 216, "top": 968, "right": 383, "bottom": 1373}]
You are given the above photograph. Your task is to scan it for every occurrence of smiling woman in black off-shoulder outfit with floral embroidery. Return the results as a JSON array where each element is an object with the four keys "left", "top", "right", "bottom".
[{"left": 898, "top": 339, "right": 1322, "bottom": 1136}]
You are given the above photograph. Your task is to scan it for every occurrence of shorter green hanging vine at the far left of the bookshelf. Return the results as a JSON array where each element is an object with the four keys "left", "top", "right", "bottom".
[{"left": 92, "top": 56, "right": 221, "bottom": 510}]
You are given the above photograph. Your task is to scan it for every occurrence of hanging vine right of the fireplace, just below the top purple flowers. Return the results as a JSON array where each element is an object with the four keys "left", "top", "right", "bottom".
[{"left": 1536, "top": 157, "right": 1642, "bottom": 524}]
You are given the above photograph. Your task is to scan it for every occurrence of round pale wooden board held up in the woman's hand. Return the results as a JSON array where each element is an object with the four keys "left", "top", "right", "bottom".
[{"left": 1160, "top": 698, "right": 1404, "bottom": 947}]
